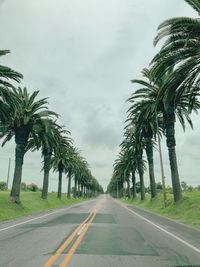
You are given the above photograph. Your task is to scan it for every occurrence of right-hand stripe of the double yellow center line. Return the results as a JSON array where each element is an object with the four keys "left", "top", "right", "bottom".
[{"left": 59, "top": 201, "right": 103, "bottom": 267}]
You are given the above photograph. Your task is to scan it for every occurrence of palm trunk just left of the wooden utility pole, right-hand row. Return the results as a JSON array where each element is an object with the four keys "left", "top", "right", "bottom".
[{"left": 146, "top": 138, "right": 157, "bottom": 199}]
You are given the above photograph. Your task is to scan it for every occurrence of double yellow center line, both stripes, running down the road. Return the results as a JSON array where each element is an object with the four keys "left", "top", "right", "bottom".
[{"left": 43, "top": 200, "right": 103, "bottom": 267}]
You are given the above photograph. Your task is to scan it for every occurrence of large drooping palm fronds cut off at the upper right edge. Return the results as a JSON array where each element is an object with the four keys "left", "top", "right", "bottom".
[{"left": 151, "top": 0, "right": 200, "bottom": 100}]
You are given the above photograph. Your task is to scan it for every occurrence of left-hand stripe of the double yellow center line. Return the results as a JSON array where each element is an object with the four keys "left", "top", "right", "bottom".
[{"left": 43, "top": 201, "right": 102, "bottom": 267}]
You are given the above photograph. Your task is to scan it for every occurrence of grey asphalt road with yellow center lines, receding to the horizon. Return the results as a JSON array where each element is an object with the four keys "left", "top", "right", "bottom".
[{"left": 0, "top": 196, "right": 200, "bottom": 267}]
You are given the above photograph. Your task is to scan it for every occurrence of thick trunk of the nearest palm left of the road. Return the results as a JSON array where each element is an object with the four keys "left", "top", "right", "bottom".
[{"left": 10, "top": 126, "right": 30, "bottom": 204}]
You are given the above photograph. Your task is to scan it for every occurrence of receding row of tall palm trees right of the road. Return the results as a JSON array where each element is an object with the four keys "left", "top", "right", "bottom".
[{"left": 107, "top": 0, "right": 200, "bottom": 203}]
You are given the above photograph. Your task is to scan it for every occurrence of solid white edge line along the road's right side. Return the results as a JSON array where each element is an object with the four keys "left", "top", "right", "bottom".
[{"left": 118, "top": 203, "right": 200, "bottom": 253}]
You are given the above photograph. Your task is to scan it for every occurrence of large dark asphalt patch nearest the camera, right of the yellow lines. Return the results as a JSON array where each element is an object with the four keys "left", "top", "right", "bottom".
[{"left": 76, "top": 225, "right": 159, "bottom": 256}]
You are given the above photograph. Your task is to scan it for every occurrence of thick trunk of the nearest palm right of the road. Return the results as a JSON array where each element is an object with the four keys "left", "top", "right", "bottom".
[{"left": 163, "top": 107, "right": 182, "bottom": 203}]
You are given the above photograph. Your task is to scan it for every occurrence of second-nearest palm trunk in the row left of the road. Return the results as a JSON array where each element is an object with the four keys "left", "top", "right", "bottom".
[{"left": 41, "top": 151, "right": 51, "bottom": 199}]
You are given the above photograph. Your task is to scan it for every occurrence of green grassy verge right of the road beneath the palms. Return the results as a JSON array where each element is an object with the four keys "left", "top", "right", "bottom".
[{"left": 121, "top": 192, "right": 200, "bottom": 229}]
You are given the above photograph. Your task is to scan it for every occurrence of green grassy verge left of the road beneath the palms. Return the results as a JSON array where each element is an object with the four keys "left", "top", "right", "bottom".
[{"left": 0, "top": 191, "right": 92, "bottom": 221}]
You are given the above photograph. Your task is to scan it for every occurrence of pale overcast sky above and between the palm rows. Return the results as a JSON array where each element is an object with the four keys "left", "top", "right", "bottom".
[{"left": 0, "top": 0, "right": 200, "bottom": 191}]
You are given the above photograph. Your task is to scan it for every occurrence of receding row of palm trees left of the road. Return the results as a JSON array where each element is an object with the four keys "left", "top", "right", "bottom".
[{"left": 0, "top": 50, "right": 103, "bottom": 204}]
